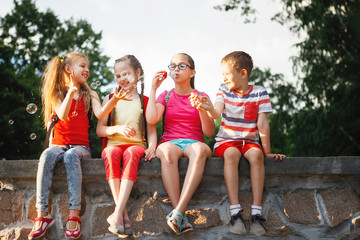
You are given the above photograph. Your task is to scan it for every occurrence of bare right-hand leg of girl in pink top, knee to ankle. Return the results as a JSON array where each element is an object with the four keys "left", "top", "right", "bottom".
[{"left": 176, "top": 142, "right": 211, "bottom": 214}]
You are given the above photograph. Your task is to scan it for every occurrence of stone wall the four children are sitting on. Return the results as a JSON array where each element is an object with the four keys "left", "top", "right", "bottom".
[{"left": 0, "top": 157, "right": 360, "bottom": 240}]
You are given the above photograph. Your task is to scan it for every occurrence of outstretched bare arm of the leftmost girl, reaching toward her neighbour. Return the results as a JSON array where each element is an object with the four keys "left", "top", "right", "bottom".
[{"left": 90, "top": 88, "right": 131, "bottom": 119}]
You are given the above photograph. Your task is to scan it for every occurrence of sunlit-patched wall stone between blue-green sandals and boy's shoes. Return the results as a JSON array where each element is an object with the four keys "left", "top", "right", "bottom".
[{"left": 185, "top": 208, "right": 223, "bottom": 229}]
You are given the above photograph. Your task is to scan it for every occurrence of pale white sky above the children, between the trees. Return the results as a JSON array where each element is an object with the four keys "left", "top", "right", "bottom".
[{"left": 0, "top": 0, "right": 300, "bottom": 100}]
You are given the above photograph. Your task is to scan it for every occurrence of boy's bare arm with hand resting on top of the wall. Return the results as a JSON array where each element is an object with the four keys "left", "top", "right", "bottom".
[{"left": 257, "top": 112, "right": 286, "bottom": 160}]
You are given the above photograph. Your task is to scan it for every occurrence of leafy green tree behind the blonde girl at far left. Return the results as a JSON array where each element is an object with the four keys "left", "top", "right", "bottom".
[{"left": 0, "top": 0, "right": 113, "bottom": 159}]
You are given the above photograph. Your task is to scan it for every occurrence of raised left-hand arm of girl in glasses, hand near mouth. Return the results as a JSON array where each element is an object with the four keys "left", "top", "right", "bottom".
[{"left": 145, "top": 71, "right": 165, "bottom": 124}]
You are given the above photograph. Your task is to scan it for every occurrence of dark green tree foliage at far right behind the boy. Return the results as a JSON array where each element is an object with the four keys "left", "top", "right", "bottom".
[{"left": 215, "top": 0, "right": 360, "bottom": 156}]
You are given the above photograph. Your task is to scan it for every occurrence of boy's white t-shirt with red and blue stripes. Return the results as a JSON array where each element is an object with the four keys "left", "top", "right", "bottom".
[{"left": 214, "top": 84, "right": 272, "bottom": 148}]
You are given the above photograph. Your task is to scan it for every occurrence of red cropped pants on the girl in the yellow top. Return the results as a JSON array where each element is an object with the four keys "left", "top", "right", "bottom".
[{"left": 101, "top": 145, "right": 145, "bottom": 182}]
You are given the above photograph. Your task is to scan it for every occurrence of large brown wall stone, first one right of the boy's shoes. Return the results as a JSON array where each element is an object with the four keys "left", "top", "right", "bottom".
[{"left": 281, "top": 190, "right": 320, "bottom": 224}]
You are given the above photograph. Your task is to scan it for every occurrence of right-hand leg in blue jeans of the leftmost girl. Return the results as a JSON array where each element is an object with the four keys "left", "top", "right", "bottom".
[{"left": 64, "top": 146, "right": 91, "bottom": 229}]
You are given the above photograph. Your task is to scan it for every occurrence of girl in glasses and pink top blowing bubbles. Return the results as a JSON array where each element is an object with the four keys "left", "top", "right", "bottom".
[{"left": 146, "top": 53, "right": 215, "bottom": 234}]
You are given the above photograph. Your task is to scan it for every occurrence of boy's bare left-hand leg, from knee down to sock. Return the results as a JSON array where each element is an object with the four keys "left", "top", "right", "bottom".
[{"left": 224, "top": 147, "right": 241, "bottom": 205}]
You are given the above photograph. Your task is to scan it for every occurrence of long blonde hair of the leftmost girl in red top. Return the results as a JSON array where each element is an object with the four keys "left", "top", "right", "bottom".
[{"left": 41, "top": 52, "right": 91, "bottom": 128}]
